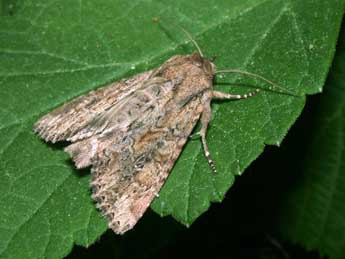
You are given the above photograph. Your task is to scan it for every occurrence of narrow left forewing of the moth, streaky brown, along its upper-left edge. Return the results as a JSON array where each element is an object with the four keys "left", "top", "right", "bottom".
[{"left": 34, "top": 71, "right": 153, "bottom": 143}]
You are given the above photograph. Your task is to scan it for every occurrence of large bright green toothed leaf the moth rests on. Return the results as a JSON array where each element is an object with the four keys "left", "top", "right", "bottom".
[{"left": 0, "top": 0, "right": 344, "bottom": 258}]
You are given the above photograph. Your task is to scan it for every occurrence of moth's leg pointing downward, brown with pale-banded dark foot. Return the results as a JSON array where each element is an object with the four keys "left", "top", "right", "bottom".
[{"left": 200, "top": 98, "right": 217, "bottom": 173}]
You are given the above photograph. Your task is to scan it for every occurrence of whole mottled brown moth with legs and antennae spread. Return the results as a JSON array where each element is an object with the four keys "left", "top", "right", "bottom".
[{"left": 34, "top": 20, "right": 290, "bottom": 234}]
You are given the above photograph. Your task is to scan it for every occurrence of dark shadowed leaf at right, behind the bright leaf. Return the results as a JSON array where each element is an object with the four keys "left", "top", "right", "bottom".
[{"left": 278, "top": 24, "right": 345, "bottom": 258}]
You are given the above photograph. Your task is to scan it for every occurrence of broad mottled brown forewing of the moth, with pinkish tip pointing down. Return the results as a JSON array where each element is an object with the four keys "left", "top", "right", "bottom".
[{"left": 91, "top": 98, "right": 202, "bottom": 234}]
